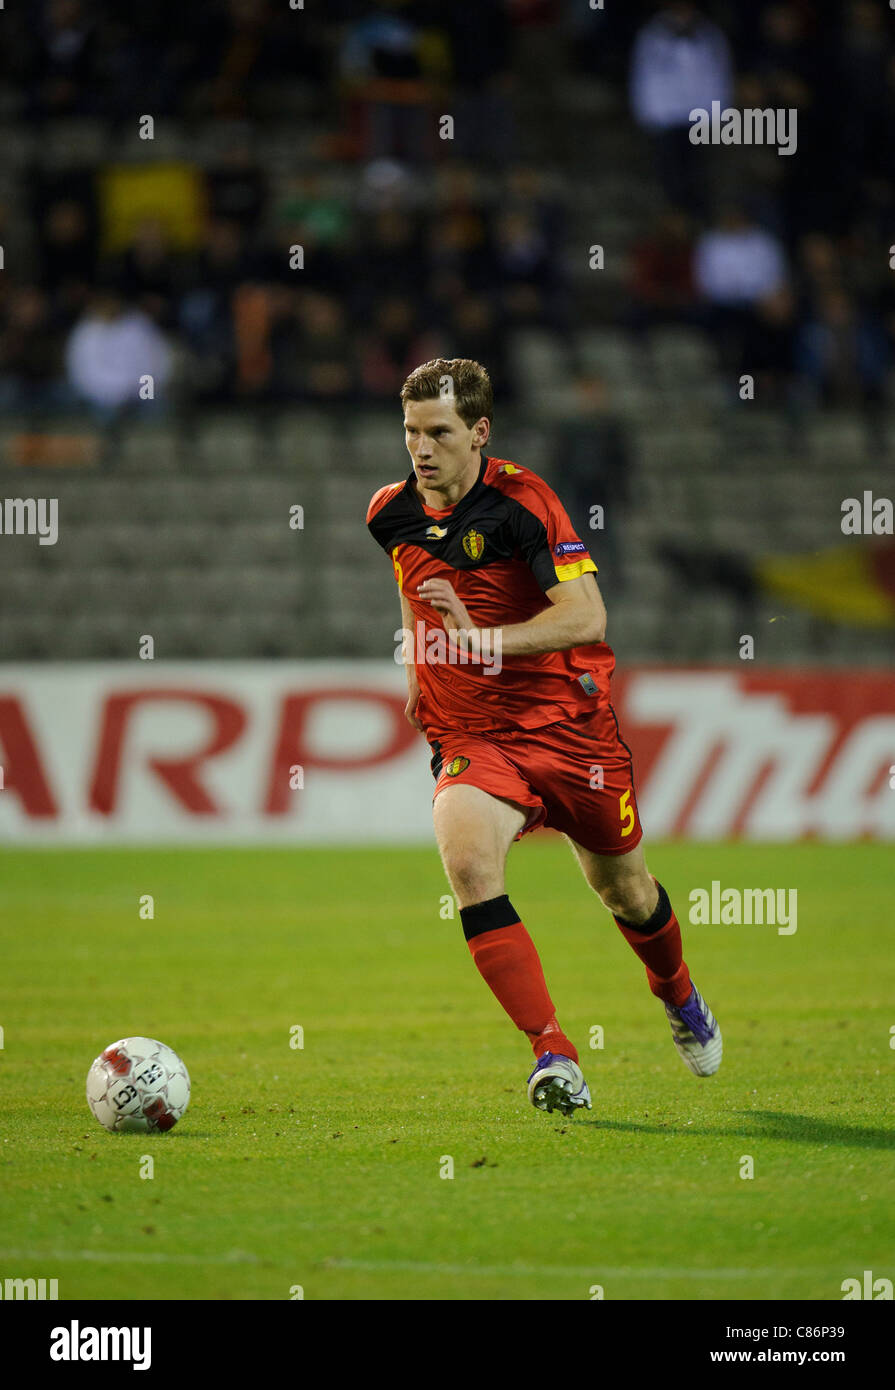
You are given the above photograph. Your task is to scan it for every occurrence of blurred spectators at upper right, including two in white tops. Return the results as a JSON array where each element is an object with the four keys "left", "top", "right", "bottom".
[{"left": 630, "top": 0, "right": 895, "bottom": 418}]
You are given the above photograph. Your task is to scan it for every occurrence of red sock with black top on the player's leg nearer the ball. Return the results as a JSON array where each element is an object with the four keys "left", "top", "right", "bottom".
[{"left": 460, "top": 894, "right": 578, "bottom": 1062}]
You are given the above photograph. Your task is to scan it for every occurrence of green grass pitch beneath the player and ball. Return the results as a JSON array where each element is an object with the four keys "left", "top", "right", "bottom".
[{"left": 0, "top": 837, "right": 895, "bottom": 1300}]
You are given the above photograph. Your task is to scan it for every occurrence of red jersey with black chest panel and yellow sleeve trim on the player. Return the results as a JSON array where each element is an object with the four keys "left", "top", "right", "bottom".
[{"left": 367, "top": 455, "right": 616, "bottom": 739}]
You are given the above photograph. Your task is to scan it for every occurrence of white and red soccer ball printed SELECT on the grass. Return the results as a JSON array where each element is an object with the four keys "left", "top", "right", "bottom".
[{"left": 88, "top": 1038, "right": 189, "bottom": 1134}]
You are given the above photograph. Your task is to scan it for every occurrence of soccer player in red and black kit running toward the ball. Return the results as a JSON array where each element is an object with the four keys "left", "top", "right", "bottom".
[{"left": 367, "top": 357, "right": 721, "bottom": 1115}]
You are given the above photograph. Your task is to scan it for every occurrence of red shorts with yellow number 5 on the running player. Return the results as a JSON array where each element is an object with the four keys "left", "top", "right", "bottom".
[{"left": 429, "top": 705, "right": 643, "bottom": 855}]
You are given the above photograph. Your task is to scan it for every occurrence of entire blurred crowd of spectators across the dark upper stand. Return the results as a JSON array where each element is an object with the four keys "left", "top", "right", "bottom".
[{"left": 0, "top": 0, "right": 895, "bottom": 417}]
